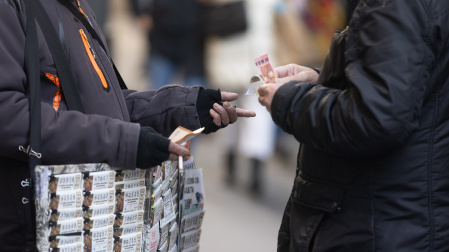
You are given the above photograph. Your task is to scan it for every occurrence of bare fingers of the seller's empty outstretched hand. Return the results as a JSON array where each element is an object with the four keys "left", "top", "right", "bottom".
[{"left": 210, "top": 91, "right": 256, "bottom": 126}]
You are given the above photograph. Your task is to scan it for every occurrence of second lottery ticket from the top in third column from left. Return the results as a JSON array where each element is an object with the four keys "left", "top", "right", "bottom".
[{"left": 115, "top": 187, "right": 146, "bottom": 213}]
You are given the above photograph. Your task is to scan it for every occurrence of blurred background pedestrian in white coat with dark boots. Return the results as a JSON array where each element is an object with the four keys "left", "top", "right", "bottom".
[{"left": 205, "top": 0, "right": 277, "bottom": 196}]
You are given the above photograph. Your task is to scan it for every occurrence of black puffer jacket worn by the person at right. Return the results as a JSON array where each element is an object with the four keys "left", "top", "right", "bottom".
[{"left": 272, "top": 0, "right": 449, "bottom": 252}]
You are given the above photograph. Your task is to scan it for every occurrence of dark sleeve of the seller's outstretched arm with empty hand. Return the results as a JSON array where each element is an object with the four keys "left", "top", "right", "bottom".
[{"left": 121, "top": 85, "right": 202, "bottom": 137}]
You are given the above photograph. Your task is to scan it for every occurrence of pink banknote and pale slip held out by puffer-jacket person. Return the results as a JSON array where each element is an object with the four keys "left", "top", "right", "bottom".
[{"left": 245, "top": 54, "right": 277, "bottom": 95}]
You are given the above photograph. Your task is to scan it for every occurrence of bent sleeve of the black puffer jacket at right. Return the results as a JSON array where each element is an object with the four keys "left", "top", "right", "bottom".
[{"left": 272, "top": 0, "right": 434, "bottom": 158}]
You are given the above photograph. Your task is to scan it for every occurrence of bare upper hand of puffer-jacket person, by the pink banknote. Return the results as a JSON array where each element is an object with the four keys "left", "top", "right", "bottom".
[{"left": 274, "top": 64, "right": 319, "bottom": 83}]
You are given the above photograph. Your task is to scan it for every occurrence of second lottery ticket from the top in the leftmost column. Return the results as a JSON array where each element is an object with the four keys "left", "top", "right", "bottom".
[{"left": 49, "top": 189, "right": 83, "bottom": 210}]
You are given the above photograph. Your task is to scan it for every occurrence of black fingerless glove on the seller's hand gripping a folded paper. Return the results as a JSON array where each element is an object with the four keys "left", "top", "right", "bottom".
[{"left": 136, "top": 127, "right": 170, "bottom": 168}]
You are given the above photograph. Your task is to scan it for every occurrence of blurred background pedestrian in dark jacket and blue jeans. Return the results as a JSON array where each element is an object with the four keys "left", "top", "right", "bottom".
[{"left": 132, "top": 0, "right": 206, "bottom": 88}]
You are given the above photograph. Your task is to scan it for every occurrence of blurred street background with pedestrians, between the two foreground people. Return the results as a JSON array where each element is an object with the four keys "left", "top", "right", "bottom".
[{"left": 89, "top": 0, "right": 352, "bottom": 252}]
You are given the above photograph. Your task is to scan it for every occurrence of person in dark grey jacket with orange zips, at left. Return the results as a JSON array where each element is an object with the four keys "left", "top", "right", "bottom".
[{"left": 0, "top": 0, "right": 255, "bottom": 252}]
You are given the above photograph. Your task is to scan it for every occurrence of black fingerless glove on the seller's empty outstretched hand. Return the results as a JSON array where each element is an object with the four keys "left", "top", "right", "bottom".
[{"left": 196, "top": 89, "right": 223, "bottom": 134}]
